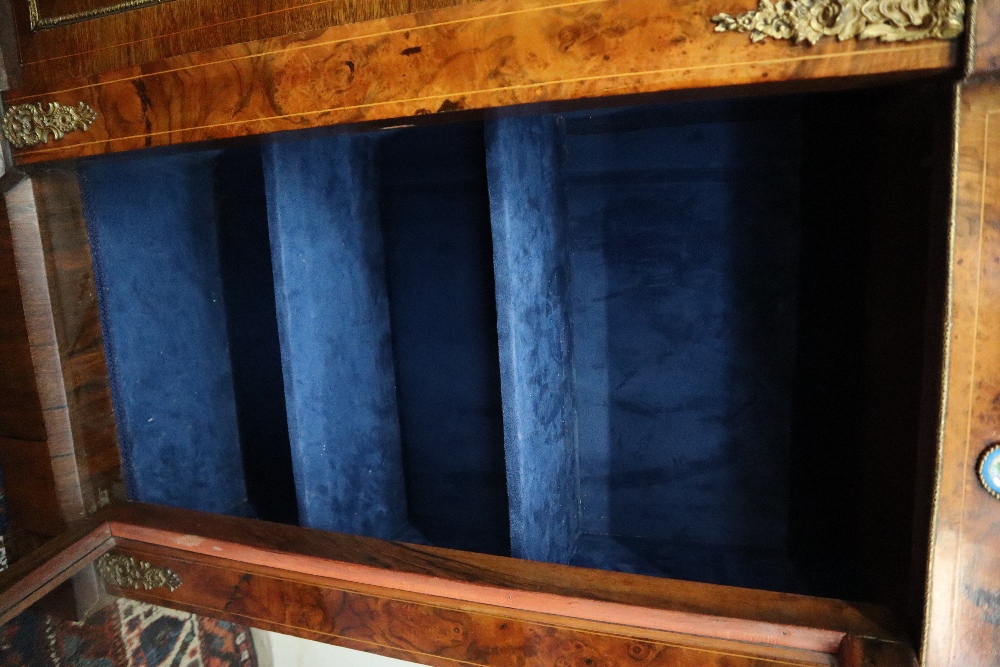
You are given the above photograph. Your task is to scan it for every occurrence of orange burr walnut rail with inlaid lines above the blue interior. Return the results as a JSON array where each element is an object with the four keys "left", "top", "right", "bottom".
[{"left": 5, "top": 0, "right": 957, "bottom": 163}]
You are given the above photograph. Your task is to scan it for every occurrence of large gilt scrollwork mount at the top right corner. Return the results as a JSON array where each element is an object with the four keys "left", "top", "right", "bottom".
[{"left": 712, "top": 0, "right": 965, "bottom": 46}]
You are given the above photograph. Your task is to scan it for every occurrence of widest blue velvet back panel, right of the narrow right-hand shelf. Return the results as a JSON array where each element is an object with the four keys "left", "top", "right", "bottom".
[{"left": 564, "top": 101, "right": 801, "bottom": 586}]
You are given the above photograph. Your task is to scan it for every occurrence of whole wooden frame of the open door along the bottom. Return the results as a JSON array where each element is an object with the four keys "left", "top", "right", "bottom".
[{"left": 0, "top": 503, "right": 912, "bottom": 666}]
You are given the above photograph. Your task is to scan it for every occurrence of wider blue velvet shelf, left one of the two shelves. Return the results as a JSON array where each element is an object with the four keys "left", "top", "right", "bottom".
[{"left": 264, "top": 135, "right": 408, "bottom": 538}]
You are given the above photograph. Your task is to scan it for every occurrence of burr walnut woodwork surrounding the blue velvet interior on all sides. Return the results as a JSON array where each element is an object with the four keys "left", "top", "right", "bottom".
[{"left": 0, "top": 0, "right": 988, "bottom": 666}]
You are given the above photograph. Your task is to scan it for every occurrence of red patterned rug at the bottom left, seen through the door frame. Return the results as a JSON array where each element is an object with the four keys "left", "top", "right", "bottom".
[{"left": 0, "top": 599, "right": 258, "bottom": 667}]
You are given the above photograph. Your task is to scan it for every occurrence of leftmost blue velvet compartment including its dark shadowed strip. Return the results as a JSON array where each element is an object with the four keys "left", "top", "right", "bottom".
[{"left": 80, "top": 149, "right": 295, "bottom": 521}]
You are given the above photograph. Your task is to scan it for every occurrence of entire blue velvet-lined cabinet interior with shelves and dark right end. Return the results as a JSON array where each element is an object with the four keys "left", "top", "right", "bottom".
[{"left": 78, "top": 81, "right": 951, "bottom": 620}]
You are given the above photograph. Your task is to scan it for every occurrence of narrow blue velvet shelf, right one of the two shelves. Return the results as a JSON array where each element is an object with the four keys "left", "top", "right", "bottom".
[{"left": 486, "top": 116, "right": 580, "bottom": 562}]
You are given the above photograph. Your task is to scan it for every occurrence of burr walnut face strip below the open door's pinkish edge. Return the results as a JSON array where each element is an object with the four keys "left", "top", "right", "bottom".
[{"left": 103, "top": 541, "right": 833, "bottom": 667}]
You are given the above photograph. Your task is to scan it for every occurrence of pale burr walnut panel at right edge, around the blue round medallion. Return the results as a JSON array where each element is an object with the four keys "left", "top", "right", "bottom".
[{"left": 923, "top": 73, "right": 1000, "bottom": 667}]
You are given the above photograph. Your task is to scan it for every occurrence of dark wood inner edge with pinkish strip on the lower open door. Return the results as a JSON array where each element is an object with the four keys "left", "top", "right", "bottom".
[{"left": 100, "top": 503, "right": 897, "bottom": 652}]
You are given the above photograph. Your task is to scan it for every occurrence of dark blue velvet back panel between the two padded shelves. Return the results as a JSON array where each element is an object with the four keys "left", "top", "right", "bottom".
[{"left": 377, "top": 123, "right": 510, "bottom": 554}]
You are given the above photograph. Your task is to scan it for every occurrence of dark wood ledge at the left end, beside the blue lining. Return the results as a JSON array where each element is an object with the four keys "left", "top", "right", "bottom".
[{"left": 4, "top": 170, "right": 125, "bottom": 534}]
